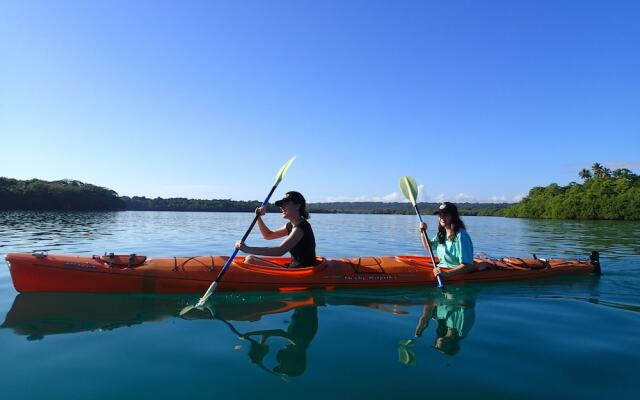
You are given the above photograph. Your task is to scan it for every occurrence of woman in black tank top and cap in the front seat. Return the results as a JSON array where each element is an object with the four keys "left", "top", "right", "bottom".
[{"left": 236, "top": 192, "right": 316, "bottom": 267}]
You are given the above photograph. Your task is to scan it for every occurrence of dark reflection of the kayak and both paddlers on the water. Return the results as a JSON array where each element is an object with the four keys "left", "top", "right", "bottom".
[{"left": 1, "top": 289, "right": 475, "bottom": 377}]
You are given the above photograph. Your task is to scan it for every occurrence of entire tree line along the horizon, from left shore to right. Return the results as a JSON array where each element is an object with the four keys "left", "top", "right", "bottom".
[{"left": 0, "top": 163, "right": 640, "bottom": 220}]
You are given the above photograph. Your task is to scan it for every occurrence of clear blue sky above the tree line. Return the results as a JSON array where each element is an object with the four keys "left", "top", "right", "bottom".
[{"left": 0, "top": 0, "right": 640, "bottom": 201}]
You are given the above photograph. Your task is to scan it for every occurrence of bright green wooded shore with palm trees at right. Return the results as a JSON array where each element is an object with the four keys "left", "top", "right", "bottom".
[{"left": 504, "top": 163, "right": 640, "bottom": 220}]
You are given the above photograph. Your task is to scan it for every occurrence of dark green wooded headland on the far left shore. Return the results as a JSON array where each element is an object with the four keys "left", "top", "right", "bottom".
[{"left": 0, "top": 177, "right": 124, "bottom": 211}]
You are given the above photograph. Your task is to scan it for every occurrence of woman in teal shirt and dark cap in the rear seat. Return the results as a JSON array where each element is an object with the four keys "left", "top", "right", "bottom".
[{"left": 420, "top": 201, "right": 475, "bottom": 278}]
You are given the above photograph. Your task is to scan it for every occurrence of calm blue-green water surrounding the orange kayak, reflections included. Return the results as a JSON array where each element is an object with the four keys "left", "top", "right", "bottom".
[{"left": 0, "top": 212, "right": 640, "bottom": 399}]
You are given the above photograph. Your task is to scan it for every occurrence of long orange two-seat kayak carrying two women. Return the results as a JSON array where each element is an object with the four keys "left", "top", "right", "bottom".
[{"left": 5, "top": 251, "right": 600, "bottom": 293}]
